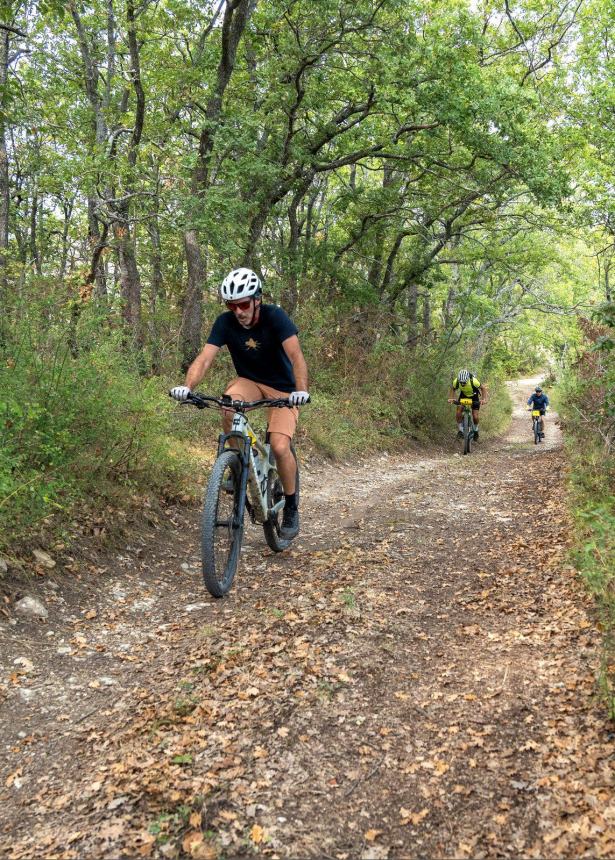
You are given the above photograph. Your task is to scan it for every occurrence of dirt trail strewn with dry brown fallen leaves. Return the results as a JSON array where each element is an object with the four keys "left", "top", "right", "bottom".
[{"left": 0, "top": 380, "right": 615, "bottom": 860}]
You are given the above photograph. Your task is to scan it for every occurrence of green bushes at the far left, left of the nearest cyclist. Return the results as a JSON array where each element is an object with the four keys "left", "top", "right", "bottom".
[{"left": 0, "top": 316, "right": 188, "bottom": 546}]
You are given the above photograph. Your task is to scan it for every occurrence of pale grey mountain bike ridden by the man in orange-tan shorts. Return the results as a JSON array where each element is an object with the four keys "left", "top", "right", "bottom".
[{"left": 178, "top": 393, "right": 299, "bottom": 597}]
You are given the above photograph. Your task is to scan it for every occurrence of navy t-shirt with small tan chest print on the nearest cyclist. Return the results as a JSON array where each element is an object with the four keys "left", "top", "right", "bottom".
[{"left": 207, "top": 305, "right": 298, "bottom": 392}]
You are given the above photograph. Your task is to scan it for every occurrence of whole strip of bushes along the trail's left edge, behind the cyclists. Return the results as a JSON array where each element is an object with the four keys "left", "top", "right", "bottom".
[{"left": 0, "top": 310, "right": 510, "bottom": 554}]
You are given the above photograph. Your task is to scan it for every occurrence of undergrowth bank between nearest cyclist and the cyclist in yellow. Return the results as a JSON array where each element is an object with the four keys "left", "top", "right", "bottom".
[{"left": 300, "top": 324, "right": 511, "bottom": 458}]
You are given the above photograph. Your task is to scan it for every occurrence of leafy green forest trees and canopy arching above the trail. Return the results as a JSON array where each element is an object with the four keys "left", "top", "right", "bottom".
[{"left": 0, "top": 0, "right": 614, "bottom": 373}]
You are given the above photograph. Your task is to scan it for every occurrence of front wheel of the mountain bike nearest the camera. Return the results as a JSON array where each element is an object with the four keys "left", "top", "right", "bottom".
[{"left": 201, "top": 451, "right": 243, "bottom": 597}]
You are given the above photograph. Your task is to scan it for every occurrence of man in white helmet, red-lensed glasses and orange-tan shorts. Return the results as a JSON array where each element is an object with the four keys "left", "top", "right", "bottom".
[{"left": 170, "top": 268, "right": 309, "bottom": 540}]
